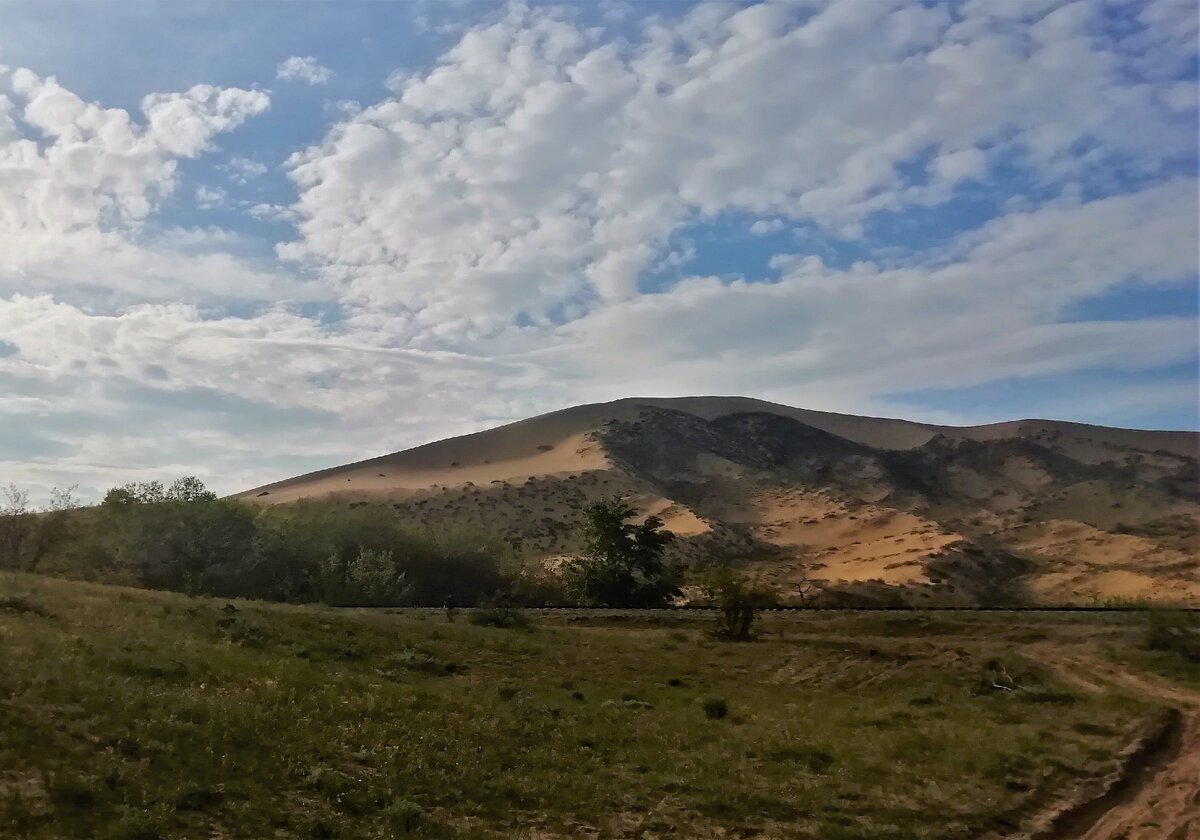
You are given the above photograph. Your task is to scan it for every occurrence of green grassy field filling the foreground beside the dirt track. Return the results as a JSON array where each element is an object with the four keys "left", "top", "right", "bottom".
[{"left": 0, "top": 575, "right": 1180, "bottom": 840}]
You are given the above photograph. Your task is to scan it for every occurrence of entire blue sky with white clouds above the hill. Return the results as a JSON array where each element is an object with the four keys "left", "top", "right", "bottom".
[{"left": 0, "top": 0, "right": 1200, "bottom": 499}]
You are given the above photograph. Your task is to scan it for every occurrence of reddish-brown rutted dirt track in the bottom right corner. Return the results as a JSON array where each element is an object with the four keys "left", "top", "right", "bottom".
[{"left": 1036, "top": 649, "right": 1200, "bottom": 840}]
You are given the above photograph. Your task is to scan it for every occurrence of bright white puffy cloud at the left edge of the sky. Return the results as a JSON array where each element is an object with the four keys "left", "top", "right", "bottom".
[{"left": 0, "top": 68, "right": 300, "bottom": 306}]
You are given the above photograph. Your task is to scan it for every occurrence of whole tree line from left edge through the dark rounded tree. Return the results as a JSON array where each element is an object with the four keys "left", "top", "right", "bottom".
[{"left": 0, "top": 476, "right": 710, "bottom": 607}]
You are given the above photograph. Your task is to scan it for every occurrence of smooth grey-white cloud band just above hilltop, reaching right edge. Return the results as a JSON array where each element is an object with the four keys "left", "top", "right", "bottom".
[{"left": 544, "top": 179, "right": 1200, "bottom": 409}]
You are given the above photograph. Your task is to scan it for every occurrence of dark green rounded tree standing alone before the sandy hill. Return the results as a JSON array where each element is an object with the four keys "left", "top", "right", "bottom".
[{"left": 563, "top": 496, "right": 680, "bottom": 607}]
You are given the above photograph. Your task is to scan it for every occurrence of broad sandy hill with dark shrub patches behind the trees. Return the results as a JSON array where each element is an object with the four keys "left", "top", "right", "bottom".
[{"left": 240, "top": 397, "right": 1200, "bottom": 605}]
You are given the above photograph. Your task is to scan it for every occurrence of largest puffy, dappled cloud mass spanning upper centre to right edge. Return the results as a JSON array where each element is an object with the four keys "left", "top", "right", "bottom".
[{"left": 281, "top": 0, "right": 1195, "bottom": 337}]
